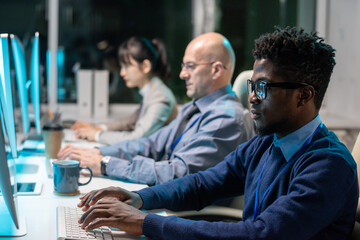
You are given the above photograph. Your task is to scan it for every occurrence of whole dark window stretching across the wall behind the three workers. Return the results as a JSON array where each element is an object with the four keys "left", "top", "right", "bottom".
[{"left": 0, "top": 0, "right": 316, "bottom": 106}]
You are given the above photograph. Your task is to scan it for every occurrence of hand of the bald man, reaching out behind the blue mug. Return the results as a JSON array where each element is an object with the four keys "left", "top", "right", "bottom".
[{"left": 58, "top": 144, "right": 103, "bottom": 176}]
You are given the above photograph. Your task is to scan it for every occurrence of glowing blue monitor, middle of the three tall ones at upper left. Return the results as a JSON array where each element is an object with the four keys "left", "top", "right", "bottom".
[{"left": 10, "top": 34, "right": 30, "bottom": 136}]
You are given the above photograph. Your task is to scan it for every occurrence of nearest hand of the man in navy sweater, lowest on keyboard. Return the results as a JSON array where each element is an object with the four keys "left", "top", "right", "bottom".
[{"left": 79, "top": 198, "right": 147, "bottom": 235}]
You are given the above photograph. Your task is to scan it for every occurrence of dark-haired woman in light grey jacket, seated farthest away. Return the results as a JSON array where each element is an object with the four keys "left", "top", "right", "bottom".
[{"left": 72, "top": 37, "right": 177, "bottom": 145}]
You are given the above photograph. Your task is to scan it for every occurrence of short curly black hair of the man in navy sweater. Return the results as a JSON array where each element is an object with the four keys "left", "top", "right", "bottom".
[{"left": 253, "top": 27, "right": 336, "bottom": 109}]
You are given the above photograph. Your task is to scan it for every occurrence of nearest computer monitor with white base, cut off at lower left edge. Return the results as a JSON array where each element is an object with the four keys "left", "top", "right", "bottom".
[{"left": 0, "top": 110, "right": 27, "bottom": 237}]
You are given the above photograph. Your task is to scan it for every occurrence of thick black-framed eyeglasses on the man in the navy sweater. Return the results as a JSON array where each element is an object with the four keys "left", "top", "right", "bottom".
[{"left": 247, "top": 79, "right": 309, "bottom": 100}]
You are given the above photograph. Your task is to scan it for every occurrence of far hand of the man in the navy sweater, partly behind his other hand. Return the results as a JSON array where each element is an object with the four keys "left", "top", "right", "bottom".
[{"left": 78, "top": 187, "right": 143, "bottom": 211}]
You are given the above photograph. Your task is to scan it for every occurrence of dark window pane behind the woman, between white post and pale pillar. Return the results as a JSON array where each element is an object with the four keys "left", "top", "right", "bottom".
[{"left": 58, "top": 0, "right": 192, "bottom": 103}]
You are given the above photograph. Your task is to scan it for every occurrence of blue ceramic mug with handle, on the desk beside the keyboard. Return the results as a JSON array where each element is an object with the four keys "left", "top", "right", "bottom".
[{"left": 53, "top": 160, "right": 93, "bottom": 196}]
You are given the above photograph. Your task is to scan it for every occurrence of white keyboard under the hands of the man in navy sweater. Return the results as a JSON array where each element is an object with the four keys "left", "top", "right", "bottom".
[{"left": 57, "top": 206, "right": 114, "bottom": 240}]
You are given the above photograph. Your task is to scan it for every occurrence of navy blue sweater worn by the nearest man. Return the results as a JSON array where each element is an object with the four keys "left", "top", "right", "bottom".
[{"left": 138, "top": 126, "right": 359, "bottom": 240}]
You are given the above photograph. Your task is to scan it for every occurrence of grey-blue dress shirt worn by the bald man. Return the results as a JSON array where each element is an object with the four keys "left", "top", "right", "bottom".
[{"left": 99, "top": 84, "right": 254, "bottom": 185}]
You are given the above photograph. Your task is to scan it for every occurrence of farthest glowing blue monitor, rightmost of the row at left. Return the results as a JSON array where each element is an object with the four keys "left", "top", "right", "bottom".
[{"left": 30, "top": 32, "right": 41, "bottom": 135}]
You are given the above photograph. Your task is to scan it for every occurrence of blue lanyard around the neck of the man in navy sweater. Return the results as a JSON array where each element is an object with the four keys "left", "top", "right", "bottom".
[{"left": 253, "top": 123, "right": 323, "bottom": 220}]
